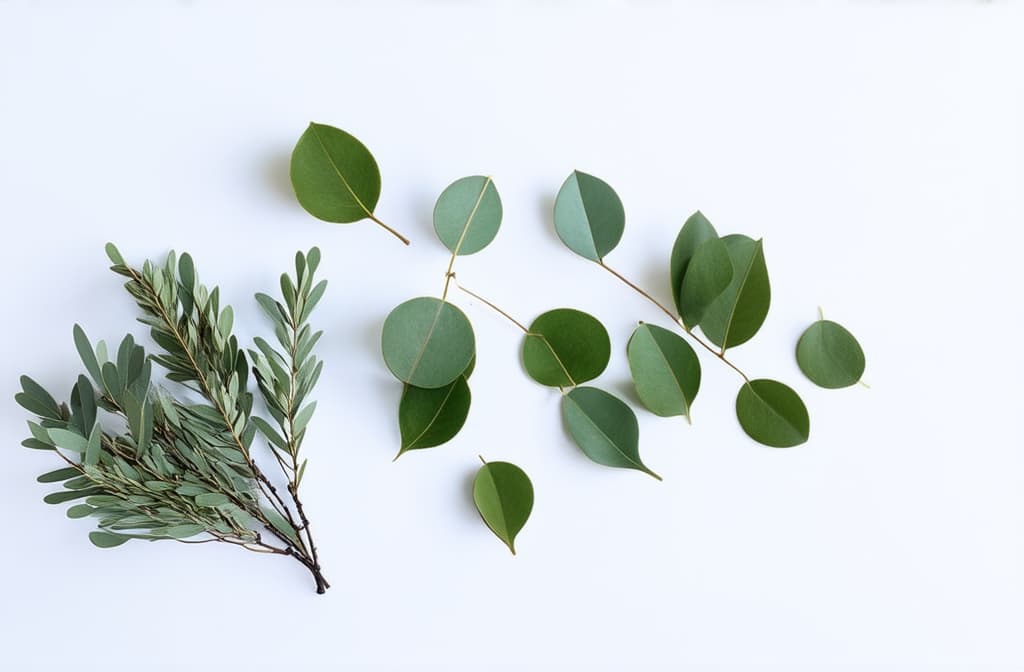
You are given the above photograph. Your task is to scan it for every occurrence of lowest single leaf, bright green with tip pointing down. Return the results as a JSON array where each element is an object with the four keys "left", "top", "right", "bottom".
[{"left": 473, "top": 462, "right": 534, "bottom": 555}]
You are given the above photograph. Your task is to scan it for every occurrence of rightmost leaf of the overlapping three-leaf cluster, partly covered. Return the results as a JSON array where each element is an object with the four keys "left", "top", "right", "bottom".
[{"left": 696, "top": 235, "right": 771, "bottom": 350}]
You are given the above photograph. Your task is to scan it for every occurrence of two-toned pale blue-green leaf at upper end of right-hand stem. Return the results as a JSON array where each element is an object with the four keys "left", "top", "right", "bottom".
[{"left": 555, "top": 170, "right": 626, "bottom": 261}]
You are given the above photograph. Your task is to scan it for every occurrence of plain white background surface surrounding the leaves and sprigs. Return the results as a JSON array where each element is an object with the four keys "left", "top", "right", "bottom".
[{"left": 0, "top": 1, "right": 1024, "bottom": 670}]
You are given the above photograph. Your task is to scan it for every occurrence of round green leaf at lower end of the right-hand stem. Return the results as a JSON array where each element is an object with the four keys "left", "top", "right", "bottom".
[{"left": 736, "top": 378, "right": 811, "bottom": 448}]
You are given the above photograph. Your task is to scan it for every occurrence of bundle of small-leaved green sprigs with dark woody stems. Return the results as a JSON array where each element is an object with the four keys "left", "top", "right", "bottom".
[{"left": 16, "top": 245, "right": 329, "bottom": 593}]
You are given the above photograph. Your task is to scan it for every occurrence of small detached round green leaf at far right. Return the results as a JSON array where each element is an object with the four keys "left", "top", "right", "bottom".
[{"left": 797, "top": 320, "right": 864, "bottom": 389}]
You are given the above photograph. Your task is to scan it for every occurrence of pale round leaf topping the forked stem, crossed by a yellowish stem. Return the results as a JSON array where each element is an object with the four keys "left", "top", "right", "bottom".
[{"left": 434, "top": 175, "right": 502, "bottom": 254}]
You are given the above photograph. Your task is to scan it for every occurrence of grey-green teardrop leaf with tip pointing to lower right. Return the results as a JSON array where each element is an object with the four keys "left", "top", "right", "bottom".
[{"left": 562, "top": 387, "right": 662, "bottom": 480}]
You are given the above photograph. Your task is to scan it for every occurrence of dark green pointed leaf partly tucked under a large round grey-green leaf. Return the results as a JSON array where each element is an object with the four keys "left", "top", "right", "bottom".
[{"left": 398, "top": 375, "right": 471, "bottom": 455}]
